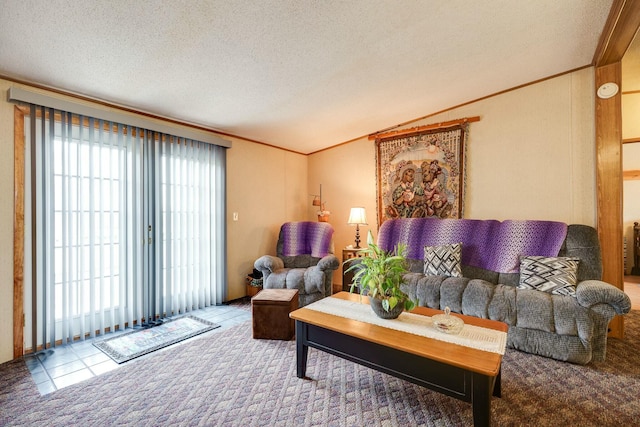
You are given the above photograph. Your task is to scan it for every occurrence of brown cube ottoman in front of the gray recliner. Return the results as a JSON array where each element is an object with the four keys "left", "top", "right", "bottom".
[{"left": 251, "top": 289, "right": 298, "bottom": 340}]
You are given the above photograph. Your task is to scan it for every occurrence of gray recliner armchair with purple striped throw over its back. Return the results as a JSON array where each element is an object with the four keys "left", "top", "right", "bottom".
[{"left": 254, "top": 221, "right": 340, "bottom": 307}]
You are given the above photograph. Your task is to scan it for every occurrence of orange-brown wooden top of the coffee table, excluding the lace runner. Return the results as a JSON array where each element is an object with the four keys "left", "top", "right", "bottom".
[{"left": 290, "top": 292, "right": 508, "bottom": 376}]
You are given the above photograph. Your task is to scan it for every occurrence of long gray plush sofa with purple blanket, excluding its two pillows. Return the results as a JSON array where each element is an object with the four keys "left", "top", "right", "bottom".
[{"left": 378, "top": 218, "right": 631, "bottom": 364}]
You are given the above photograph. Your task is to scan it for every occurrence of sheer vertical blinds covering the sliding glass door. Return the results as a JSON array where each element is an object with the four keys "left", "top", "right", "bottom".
[{"left": 25, "top": 105, "right": 227, "bottom": 349}]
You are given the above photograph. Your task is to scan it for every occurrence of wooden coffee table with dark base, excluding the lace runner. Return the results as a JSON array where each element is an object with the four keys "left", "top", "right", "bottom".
[{"left": 290, "top": 292, "right": 508, "bottom": 426}]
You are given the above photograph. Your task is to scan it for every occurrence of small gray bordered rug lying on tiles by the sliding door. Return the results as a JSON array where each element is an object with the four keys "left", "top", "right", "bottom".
[{"left": 93, "top": 316, "right": 220, "bottom": 363}]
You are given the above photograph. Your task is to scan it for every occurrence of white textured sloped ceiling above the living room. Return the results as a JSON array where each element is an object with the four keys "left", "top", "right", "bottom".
[{"left": 0, "top": 0, "right": 612, "bottom": 153}]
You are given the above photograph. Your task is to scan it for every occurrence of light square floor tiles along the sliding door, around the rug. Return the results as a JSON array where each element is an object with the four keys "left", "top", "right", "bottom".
[{"left": 25, "top": 305, "right": 251, "bottom": 395}]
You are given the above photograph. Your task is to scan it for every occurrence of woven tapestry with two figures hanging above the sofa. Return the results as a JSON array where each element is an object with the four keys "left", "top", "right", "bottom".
[{"left": 376, "top": 124, "right": 468, "bottom": 224}]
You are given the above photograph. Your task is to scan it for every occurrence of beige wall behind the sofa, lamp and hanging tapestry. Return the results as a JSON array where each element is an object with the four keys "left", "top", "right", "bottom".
[{"left": 309, "top": 68, "right": 596, "bottom": 283}]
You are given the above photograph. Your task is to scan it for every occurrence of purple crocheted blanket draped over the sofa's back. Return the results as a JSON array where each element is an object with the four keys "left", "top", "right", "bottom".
[{"left": 378, "top": 218, "right": 567, "bottom": 273}]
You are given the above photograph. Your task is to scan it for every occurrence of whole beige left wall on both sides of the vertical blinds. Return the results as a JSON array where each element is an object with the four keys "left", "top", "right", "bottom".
[{"left": 0, "top": 79, "right": 310, "bottom": 363}]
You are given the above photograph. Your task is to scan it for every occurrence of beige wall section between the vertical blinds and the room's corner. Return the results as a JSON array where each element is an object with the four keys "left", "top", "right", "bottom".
[{"left": 227, "top": 139, "right": 311, "bottom": 300}]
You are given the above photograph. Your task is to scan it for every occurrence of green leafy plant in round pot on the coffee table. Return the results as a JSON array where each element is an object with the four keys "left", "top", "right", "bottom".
[{"left": 347, "top": 230, "right": 415, "bottom": 319}]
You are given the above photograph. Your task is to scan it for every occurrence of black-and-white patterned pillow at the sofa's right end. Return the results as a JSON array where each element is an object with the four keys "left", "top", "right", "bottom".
[{"left": 518, "top": 256, "right": 580, "bottom": 297}]
